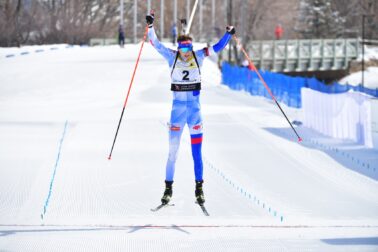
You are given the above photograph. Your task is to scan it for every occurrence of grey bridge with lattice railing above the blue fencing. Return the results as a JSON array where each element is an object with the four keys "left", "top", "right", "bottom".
[{"left": 229, "top": 38, "right": 360, "bottom": 73}]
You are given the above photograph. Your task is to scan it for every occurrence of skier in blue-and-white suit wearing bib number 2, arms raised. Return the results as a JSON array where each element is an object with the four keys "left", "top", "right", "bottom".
[{"left": 146, "top": 13, "right": 235, "bottom": 206}]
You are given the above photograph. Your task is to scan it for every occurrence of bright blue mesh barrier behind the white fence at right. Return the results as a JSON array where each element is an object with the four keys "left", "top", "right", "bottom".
[{"left": 222, "top": 62, "right": 378, "bottom": 108}]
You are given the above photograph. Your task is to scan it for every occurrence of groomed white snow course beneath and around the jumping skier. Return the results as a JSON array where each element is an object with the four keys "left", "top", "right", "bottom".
[{"left": 0, "top": 44, "right": 378, "bottom": 251}]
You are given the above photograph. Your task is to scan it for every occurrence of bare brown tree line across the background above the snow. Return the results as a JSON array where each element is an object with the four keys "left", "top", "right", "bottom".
[{"left": 0, "top": 0, "right": 378, "bottom": 47}]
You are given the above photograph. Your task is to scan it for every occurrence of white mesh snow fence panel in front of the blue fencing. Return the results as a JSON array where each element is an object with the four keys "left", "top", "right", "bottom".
[{"left": 302, "top": 88, "right": 378, "bottom": 149}]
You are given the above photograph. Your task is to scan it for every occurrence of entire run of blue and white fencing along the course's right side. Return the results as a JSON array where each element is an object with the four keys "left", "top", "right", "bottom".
[{"left": 222, "top": 63, "right": 378, "bottom": 149}]
